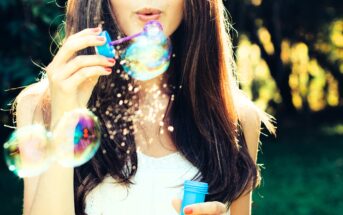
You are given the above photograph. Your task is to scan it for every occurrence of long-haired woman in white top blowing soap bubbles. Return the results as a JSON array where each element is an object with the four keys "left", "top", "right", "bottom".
[{"left": 16, "top": 0, "right": 273, "bottom": 215}]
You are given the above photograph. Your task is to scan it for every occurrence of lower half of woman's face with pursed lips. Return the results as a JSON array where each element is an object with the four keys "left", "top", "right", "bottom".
[{"left": 110, "top": 0, "right": 184, "bottom": 36}]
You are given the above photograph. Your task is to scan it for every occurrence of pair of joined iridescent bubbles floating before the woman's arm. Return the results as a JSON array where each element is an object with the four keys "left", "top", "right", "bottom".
[{"left": 4, "top": 109, "right": 101, "bottom": 178}]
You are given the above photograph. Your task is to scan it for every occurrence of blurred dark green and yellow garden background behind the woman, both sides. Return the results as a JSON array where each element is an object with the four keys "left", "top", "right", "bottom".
[{"left": 0, "top": 0, "right": 343, "bottom": 215}]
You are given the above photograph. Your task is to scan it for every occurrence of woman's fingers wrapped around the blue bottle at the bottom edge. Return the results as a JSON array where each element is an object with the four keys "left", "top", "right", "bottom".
[{"left": 183, "top": 201, "right": 226, "bottom": 215}]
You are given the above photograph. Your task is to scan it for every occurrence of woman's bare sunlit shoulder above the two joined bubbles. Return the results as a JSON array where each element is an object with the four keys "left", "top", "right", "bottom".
[{"left": 15, "top": 81, "right": 47, "bottom": 127}]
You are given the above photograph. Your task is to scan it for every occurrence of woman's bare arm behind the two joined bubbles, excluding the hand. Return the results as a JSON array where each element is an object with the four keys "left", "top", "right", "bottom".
[{"left": 16, "top": 87, "right": 74, "bottom": 215}]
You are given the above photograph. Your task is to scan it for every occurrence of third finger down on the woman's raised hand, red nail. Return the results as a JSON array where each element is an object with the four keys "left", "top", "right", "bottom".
[{"left": 54, "top": 55, "right": 115, "bottom": 80}]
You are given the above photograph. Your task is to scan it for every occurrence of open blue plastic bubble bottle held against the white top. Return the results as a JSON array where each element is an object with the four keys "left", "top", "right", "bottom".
[{"left": 180, "top": 180, "right": 208, "bottom": 215}]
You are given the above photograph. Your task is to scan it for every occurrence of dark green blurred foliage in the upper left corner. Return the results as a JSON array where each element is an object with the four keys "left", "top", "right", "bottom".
[{"left": 0, "top": 0, "right": 65, "bottom": 109}]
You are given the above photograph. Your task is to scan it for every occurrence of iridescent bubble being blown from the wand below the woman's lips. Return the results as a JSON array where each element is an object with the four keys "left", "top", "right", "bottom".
[{"left": 121, "top": 22, "right": 172, "bottom": 81}]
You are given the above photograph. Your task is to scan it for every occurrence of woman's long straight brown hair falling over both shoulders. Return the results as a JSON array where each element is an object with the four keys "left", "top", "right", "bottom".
[{"left": 20, "top": 0, "right": 272, "bottom": 214}]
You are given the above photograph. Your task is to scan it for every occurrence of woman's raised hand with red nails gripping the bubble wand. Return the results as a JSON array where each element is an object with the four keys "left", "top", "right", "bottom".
[{"left": 46, "top": 28, "right": 115, "bottom": 126}]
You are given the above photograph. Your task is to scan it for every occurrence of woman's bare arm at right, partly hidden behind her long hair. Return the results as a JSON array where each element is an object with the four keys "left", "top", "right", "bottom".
[{"left": 230, "top": 101, "right": 261, "bottom": 215}]
